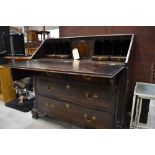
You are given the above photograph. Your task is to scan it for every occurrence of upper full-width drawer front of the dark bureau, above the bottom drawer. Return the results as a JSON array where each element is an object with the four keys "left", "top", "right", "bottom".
[{"left": 36, "top": 78, "right": 116, "bottom": 112}]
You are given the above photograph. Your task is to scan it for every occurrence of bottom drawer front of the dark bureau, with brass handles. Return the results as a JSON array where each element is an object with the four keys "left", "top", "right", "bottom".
[{"left": 36, "top": 95, "right": 113, "bottom": 128}]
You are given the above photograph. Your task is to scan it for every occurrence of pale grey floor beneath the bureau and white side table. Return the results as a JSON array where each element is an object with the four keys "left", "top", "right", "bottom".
[{"left": 0, "top": 100, "right": 155, "bottom": 129}]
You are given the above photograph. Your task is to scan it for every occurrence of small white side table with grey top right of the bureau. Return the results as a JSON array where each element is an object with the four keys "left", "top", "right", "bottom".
[{"left": 130, "top": 82, "right": 155, "bottom": 128}]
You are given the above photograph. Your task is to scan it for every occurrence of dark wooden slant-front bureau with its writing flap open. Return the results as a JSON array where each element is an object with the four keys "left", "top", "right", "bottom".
[{"left": 6, "top": 34, "right": 134, "bottom": 129}]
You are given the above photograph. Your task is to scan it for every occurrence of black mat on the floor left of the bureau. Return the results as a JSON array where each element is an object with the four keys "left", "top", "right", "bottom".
[{"left": 5, "top": 100, "right": 34, "bottom": 112}]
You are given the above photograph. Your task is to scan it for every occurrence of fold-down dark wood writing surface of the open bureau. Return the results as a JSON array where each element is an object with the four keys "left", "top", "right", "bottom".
[{"left": 8, "top": 58, "right": 124, "bottom": 78}]
